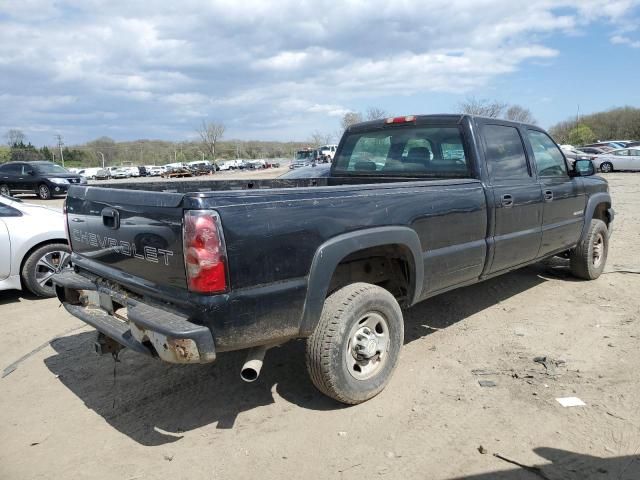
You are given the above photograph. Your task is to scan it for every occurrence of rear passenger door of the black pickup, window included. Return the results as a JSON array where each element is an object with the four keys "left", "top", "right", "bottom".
[{"left": 482, "top": 121, "right": 542, "bottom": 274}]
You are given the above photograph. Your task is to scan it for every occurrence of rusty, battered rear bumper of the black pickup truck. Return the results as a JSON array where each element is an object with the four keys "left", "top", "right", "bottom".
[{"left": 52, "top": 271, "right": 216, "bottom": 363}]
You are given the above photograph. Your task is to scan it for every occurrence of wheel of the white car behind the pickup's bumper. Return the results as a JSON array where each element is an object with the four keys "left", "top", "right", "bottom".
[{"left": 20, "top": 243, "right": 70, "bottom": 297}]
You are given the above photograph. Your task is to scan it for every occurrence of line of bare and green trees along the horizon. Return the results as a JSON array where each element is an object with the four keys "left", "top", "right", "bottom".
[{"left": 0, "top": 102, "right": 640, "bottom": 167}]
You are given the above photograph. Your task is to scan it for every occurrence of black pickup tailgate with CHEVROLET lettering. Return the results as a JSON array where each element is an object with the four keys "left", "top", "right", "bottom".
[{"left": 67, "top": 186, "right": 186, "bottom": 288}]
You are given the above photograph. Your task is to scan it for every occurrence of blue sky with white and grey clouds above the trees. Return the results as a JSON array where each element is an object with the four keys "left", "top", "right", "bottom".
[{"left": 0, "top": 0, "right": 640, "bottom": 145}]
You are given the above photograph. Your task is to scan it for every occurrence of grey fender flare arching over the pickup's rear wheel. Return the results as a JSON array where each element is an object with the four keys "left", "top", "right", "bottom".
[{"left": 300, "top": 227, "right": 424, "bottom": 336}]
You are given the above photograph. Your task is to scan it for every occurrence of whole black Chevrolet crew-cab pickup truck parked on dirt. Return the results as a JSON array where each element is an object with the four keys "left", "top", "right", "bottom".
[{"left": 54, "top": 115, "right": 613, "bottom": 404}]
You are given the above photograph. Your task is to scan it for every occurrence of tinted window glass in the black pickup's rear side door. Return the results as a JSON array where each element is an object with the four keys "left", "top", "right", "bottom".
[{"left": 482, "top": 125, "right": 531, "bottom": 183}]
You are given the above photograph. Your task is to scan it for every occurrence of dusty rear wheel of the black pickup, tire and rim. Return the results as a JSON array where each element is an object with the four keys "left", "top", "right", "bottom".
[{"left": 306, "top": 283, "right": 404, "bottom": 405}]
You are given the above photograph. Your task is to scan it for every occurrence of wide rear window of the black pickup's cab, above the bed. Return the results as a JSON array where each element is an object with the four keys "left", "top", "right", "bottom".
[{"left": 334, "top": 126, "right": 470, "bottom": 177}]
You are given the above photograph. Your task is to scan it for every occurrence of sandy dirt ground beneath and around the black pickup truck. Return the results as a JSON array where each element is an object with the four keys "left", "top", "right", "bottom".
[{"left": 0, "top": 174, "right": 640, "bottom": 480}]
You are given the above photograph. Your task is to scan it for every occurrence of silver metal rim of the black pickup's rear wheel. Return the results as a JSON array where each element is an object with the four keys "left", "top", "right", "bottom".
[{"left": 344, "top": 312, "right": 390, "bottom": 380}]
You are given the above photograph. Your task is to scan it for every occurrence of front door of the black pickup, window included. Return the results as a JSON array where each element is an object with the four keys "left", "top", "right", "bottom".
[{"left": 527, "top": 129, "right": 586, "bottom": 257}]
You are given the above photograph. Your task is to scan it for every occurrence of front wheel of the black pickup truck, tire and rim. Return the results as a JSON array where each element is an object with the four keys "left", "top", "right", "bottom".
[{"left": 569, "top": 219, "right": 609, "bottom": 280}]
